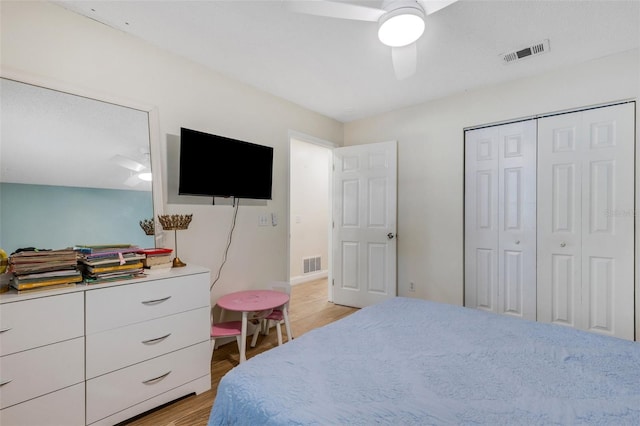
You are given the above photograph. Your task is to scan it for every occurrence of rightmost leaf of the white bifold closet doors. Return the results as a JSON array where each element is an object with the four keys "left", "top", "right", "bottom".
[{"left": 582, "top": 104, "right": 635, "bottom": 339}]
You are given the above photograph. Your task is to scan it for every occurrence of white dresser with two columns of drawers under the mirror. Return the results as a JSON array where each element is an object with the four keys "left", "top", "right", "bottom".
[{"left": 0, "top": 266, "right": 211, "bottom": 426}]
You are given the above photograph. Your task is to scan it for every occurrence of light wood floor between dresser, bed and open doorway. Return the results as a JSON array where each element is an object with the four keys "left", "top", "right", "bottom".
[{"left": 122, "top": 279, "right": 356, "bottom": 426}]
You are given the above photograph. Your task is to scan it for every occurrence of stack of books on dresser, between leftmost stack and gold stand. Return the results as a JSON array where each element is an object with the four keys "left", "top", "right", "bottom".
[{"left": 74, "top": 244, "right": 145, "bottom": 284}]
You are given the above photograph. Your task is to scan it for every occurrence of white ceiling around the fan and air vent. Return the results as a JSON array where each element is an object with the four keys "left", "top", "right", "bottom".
[{"left": 55, "top": 0, "right": 640, "bottom": 122}]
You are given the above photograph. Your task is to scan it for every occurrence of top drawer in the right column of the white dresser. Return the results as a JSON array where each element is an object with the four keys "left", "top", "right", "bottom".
[{"left": 86, "top": 273, "right": 210, "bottom": 334}]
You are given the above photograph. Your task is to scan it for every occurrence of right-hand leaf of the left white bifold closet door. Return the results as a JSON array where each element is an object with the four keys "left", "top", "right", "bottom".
[{"left": 496, "top": 121, "right": 536, "bottom": 320}]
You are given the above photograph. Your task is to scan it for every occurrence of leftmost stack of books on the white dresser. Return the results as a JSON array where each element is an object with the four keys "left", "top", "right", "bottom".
[{"left": 9, "top": 249, "right": 82, "bottom": 292}]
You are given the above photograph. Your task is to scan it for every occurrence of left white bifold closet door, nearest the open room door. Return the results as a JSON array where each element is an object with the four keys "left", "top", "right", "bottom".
[{"left": 465, "top": 120, "right": 536, "bottom": 320}]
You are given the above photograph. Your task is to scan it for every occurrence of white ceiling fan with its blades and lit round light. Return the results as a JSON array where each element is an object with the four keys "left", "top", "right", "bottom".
[{"left": 285, "top": 0, "right": 457, "bottom": 80}]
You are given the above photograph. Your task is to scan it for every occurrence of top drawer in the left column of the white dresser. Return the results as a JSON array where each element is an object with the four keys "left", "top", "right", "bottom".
[{"left": 0, "top": 292, "right": 84, "bottom": 356}]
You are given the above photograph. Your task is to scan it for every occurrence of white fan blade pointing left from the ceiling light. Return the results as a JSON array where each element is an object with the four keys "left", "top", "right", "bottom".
[{"left": 284, "top": 0, "right": 385, "bottom": 22}]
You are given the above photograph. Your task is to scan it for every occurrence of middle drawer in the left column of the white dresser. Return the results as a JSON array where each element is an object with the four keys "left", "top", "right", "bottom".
[{"left": 0, "top": 337, "right": 84, "bottom": 408}]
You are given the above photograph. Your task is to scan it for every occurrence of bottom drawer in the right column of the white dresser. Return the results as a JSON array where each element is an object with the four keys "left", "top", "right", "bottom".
[{"left": 87, "top": 341, "right": 210, "bottom": 424}]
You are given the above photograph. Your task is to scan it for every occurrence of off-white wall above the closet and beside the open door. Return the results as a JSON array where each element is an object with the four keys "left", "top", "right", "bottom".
[{"left": 344, "top": 50, "right": 640, "bottom": 318}]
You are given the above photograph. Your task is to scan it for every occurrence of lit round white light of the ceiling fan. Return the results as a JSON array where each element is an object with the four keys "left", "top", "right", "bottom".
[{"left": 378, "top": 7, "right": 424, "bottom": 47}]
